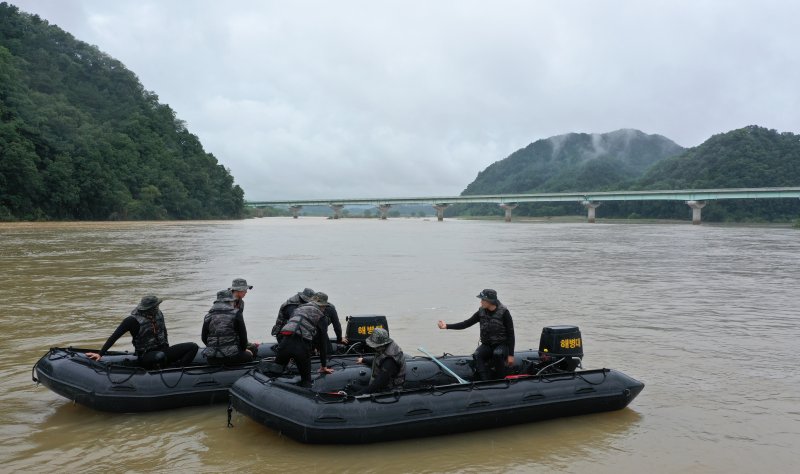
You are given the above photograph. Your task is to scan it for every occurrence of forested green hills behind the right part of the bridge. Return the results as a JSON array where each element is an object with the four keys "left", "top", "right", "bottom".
[{"left": 449, "top": 126, "right": 800, "bottom": 222}]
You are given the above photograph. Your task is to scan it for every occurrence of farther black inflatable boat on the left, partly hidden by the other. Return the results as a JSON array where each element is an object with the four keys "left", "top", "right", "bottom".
[{"left": 31, "top": 315, "right": 388, "bottom": 413}]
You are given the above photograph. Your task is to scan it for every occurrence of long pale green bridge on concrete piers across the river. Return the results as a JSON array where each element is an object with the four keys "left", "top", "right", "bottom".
[{"left": 245, "top": 187, "right": 800, "bottom": 224}]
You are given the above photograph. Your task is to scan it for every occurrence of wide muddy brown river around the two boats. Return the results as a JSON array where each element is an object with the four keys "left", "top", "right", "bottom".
[{"left": 0, "top": 218, "right": 800, "bottom": 473}]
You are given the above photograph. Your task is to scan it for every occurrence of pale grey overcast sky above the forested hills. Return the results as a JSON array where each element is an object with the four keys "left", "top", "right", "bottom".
[{"left": 11, "top": 0, "right": 800, "bottom": 200}]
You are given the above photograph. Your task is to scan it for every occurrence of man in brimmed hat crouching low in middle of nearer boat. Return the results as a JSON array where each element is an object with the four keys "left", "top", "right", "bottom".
[{"left": 356, "top": 328, "right": 406, "bottom": 395}]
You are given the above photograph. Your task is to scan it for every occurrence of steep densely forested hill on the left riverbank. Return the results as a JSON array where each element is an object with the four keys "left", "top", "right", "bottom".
[{"left": 0, "top": 2, "right": 244, "bottom": 220}]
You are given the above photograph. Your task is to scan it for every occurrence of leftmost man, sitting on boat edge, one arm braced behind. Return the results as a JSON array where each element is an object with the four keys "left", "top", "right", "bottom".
[{"left": 86, "top": 295, "right": 198, "bottom": 369}]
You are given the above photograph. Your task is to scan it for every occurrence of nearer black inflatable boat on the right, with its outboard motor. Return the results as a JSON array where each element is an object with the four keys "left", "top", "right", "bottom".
[{"left": 230, "top": 328, "right": 644, "bottom": 444}]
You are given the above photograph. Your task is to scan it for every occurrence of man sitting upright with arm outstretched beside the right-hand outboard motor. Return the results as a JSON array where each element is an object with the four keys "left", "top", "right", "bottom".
[{"left": 439, "top": 289, "right": 514, "bottom": 380}]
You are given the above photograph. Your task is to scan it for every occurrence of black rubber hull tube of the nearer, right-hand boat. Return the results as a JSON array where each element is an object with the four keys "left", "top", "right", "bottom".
[{"left": 231, "top": 360, "right": 644, "bottom": 444}]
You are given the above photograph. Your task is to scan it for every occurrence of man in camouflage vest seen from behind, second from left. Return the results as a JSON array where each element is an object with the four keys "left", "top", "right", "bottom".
[{"left": 200, "top": 290, "right": 253, "bottom": 364}]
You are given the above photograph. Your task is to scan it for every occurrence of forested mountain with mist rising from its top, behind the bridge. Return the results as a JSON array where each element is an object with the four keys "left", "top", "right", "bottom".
[{"left": 448, "top": 129, "right": 683, "bottom": 215}]
